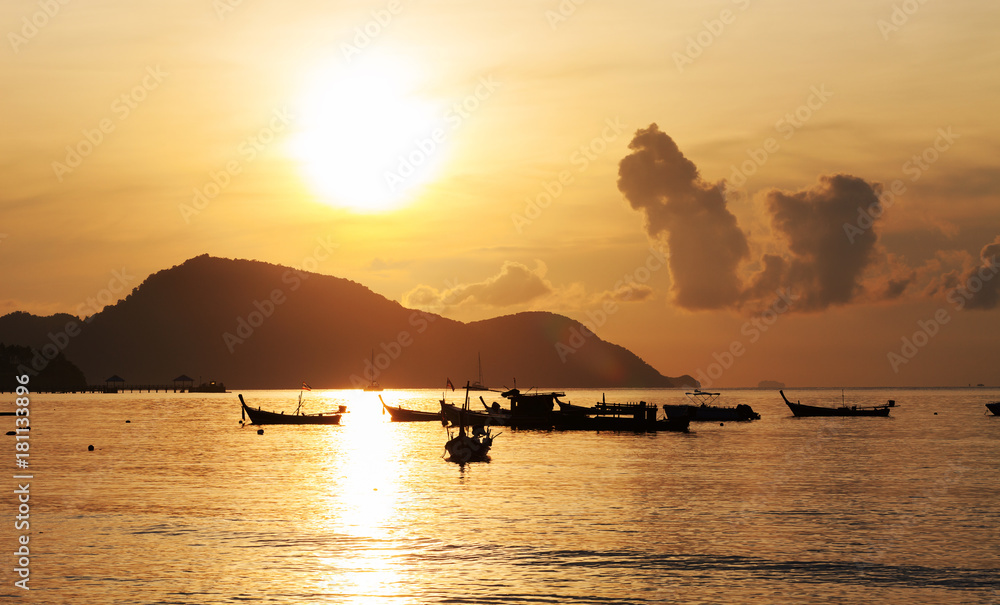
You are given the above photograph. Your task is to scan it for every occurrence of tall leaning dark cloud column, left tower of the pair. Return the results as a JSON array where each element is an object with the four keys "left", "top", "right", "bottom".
[{"left": 618, "top": 124, "right": 750, "bottom": 309}]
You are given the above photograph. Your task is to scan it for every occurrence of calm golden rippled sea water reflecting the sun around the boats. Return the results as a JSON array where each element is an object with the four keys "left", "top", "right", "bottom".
[{"left": 0, "top": 389, "right": 1000, "bottom": 605}]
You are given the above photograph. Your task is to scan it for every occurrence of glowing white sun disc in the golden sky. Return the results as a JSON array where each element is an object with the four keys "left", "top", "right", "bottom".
[{"left": 291, "top": 53, "right": 447, "bottom": 213}]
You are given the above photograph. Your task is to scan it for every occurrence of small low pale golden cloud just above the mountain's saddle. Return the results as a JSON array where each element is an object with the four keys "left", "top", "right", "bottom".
[{"left": 403, "top": 261, "right": 554, "bottom": 312}]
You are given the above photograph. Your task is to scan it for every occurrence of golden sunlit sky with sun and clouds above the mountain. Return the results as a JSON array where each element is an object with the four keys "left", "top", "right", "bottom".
[{"left": 0, "top": 0, "right": 1000, "bottom": 387}]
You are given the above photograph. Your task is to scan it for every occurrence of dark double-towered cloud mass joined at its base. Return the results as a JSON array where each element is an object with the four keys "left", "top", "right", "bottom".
[{"left": 618, "top": 124, "right": 900, "bottom": 311}]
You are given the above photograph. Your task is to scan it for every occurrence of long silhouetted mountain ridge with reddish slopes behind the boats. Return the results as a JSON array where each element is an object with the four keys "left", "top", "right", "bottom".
[{"left": 0, "top": 255, "right": 695, "bottom": 388}]
